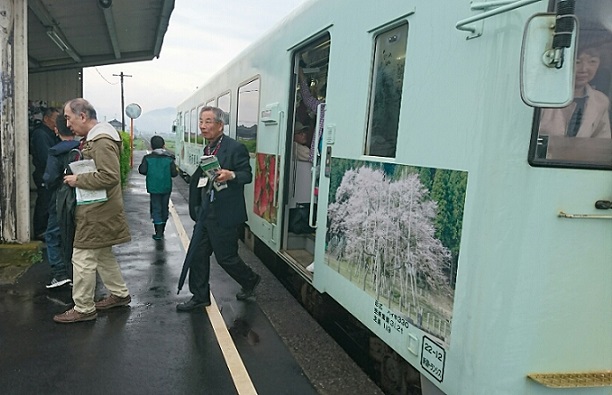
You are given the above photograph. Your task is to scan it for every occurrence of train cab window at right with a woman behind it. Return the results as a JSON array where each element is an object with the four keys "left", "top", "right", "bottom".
[{"left": 529, "top": 1, "right": 612, "bottom": 169}]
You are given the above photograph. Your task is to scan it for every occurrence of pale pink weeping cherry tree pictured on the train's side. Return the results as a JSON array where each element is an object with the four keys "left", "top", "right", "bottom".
[{"left": 328, "top": 165, "right": 451, "bottom": 338}]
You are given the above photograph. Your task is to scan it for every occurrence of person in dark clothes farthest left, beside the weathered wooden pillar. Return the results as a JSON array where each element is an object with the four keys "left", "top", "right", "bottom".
[{"left": 30, "top": 107, "right": 60, "bottom": 241}]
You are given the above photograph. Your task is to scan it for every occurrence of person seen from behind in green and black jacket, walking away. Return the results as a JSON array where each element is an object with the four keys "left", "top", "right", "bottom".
[{"left": 138, "top": 136, "right": 178, "bottom": 240}]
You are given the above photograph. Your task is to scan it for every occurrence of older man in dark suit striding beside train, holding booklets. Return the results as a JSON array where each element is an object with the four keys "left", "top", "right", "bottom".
[{"left": 176, "top": 107, "right": 261, "bottom": 311}]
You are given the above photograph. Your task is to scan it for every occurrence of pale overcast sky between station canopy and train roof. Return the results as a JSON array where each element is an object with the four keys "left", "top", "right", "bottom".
[{"left": 83, "top": 0, "right": 307, "bottom": 124}]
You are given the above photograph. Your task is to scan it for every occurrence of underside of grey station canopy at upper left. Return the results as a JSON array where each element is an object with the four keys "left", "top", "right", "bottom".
[{"left": 27, "top": 0, "right": 175, "bottom": 73}]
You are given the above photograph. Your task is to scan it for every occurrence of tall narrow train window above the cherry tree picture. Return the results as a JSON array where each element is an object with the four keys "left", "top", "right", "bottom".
[{"left": 365, "top": 24, "right": 408, "bottom": 157}]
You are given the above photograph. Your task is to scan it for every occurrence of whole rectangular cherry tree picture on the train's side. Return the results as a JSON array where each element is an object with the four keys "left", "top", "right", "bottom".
[{"left": 326, "top": 158, "right": 467, "bottom": 344}]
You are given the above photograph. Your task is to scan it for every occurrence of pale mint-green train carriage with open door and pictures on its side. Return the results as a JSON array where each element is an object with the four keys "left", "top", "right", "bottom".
[{"left": 175, "top": 0, "right": 612, "bottom": 395}]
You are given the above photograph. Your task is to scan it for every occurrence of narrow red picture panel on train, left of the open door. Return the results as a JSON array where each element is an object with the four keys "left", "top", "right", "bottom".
[{"left": 253, "top": 153, "right": 278, "bottom": 224}]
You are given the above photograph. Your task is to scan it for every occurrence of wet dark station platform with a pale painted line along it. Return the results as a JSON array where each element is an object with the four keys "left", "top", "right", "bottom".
[{"left": 0, "top": 151, "right": 382, "bottom": 394}]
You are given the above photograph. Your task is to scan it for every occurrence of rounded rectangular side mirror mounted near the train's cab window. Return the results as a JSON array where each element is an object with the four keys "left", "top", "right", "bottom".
[{"left": 521, "top": 14, "right": 578, "bottom": 108}]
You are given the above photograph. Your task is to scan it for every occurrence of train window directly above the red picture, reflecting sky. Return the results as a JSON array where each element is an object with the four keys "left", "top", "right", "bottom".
[{"left": 236, "top": 78, "right": 259, "bottom": 154}]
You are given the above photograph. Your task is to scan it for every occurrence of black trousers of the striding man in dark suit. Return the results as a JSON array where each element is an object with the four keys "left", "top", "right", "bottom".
[{"left": 185, "top": 209, "right": 256, "bottom": 302}]
